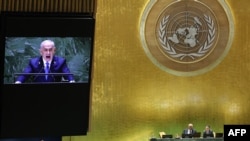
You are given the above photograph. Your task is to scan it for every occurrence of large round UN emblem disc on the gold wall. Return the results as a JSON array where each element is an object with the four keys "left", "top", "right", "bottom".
[{"left": 140, "top": 0, "right": 234, "bottom": 76}]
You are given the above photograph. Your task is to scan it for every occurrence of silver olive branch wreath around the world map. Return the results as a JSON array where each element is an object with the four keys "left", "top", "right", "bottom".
[{"left": 158, "top": 15, "right": 215, "bottom": 60}]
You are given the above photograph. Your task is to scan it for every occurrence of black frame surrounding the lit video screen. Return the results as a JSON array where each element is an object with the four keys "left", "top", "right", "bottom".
[{"left": 0, "top": 12, "right": 95, "bottom": 138}]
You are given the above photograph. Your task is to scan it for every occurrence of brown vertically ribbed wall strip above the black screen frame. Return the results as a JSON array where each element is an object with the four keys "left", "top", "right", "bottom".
[{"left": 0, "top": 0, "right": 96, "bottom": 13}]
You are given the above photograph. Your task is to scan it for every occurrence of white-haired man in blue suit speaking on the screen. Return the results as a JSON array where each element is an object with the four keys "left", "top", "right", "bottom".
[{"left": 15, "top": 40, "right": 75, "bottom": 84}]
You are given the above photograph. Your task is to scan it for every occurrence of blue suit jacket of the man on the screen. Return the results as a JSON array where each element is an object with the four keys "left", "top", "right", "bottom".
[{"left": 16, "top": 56, "right": 74, "bottom": 83}]
